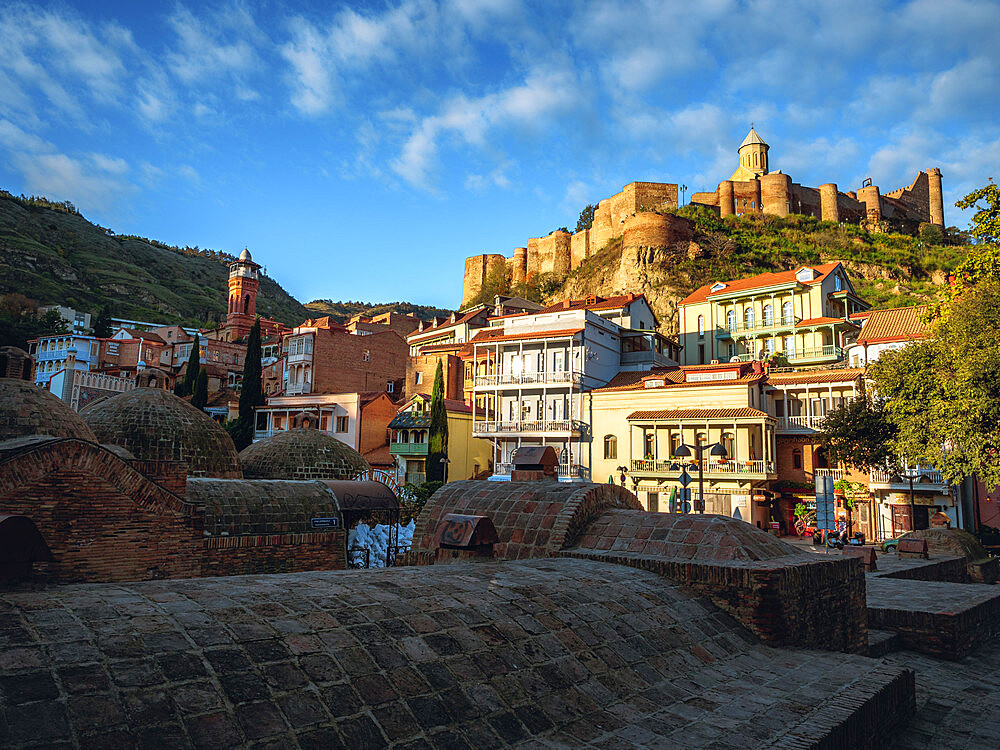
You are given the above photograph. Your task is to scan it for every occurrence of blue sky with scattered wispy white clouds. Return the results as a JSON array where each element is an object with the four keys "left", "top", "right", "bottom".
[{"left": 0, "top": 0, "right": 1000, "bottom": 307}]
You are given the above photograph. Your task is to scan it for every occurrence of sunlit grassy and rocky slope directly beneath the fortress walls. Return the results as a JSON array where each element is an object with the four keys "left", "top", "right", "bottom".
[{"left": 477, "top": 206, "right": 969, "bottom": 333}]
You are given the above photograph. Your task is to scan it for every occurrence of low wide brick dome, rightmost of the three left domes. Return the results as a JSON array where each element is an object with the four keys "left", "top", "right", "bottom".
[{"left": 240, "top": 427, "right": 371, "bottom": 479}]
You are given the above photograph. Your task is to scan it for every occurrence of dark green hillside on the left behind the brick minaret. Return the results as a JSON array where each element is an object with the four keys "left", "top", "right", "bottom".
[{"left": 0, "top": 191, "right": 309, "bottom": 326}]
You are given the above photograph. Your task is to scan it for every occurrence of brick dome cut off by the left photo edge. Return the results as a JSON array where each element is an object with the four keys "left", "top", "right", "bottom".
[{"left": 0, "top": 378, "right": 97, "bottom": 443}]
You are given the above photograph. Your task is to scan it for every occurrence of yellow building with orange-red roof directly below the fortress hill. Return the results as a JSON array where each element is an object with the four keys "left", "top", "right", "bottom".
[{"left": 678, "top": 262, "right": 870, "bottom": 366}]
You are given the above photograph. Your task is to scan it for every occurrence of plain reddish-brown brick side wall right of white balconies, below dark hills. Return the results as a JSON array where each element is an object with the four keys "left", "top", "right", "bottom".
[{"left": 312, "top": 328, "right": 409, "bottom": 393}]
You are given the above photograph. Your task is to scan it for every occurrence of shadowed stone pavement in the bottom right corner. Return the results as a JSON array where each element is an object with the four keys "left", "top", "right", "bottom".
[{"left": 882, "top": 642, "right": 1000, "bottom": 750}]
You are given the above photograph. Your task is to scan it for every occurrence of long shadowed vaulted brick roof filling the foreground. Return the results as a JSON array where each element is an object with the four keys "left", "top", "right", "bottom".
[{"left": 0, "top": 559, "right": 912, "bottom": 750}]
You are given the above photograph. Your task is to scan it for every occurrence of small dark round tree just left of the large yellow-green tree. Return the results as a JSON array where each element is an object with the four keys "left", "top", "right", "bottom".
[{"left": 819, "top": 395, "right": 898, "bottom": 471}]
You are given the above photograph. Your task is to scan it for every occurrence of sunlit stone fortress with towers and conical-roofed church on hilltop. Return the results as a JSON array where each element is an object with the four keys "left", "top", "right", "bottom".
[{"left": 462, "top": 128, "right": 944, "bottom": 304}]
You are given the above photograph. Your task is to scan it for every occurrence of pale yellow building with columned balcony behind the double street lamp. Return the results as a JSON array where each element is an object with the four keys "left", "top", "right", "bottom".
[{"left": 588, "top": 362, "right": 777, "bottom": 523}]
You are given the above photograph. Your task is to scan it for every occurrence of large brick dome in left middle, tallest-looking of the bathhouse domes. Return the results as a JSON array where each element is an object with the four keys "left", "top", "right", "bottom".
[{"left": 81, "top": 388, "right": 243, "bottom": 479}]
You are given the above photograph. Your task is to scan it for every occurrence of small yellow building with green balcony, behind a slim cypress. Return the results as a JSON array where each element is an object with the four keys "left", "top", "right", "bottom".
[{"left": 389, "top": 393, "right": 493, "bottom": 485}]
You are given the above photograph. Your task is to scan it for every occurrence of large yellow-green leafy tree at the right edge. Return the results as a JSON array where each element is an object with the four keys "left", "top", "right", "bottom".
[{"left": 869, "top": 276, "right": 1000, "bottom": 490}]
